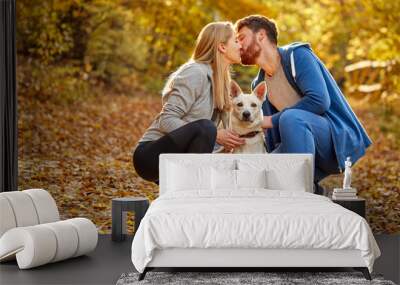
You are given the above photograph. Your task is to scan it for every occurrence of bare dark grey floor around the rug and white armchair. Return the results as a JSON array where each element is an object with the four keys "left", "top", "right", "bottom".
[{"left": 0, "top": 235, "right": 400, "bottom": 285}]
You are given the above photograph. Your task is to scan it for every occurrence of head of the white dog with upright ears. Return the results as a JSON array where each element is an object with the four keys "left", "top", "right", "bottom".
[{"left": 231, "top": 80, "right": 267, "bottom": 123}]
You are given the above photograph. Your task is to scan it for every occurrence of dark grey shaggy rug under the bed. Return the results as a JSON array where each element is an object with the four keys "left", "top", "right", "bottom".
[{"left": 117, "top": 271, "right": 396, "bottom": 285}]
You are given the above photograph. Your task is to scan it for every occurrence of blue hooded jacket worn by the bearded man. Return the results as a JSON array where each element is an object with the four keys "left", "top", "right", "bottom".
[{"left": 251, "top": 42, "right": 372, "bottom": 175}]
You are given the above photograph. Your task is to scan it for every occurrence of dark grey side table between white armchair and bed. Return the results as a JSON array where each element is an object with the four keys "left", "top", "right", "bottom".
[{"left": 111, "top": 197, "right": 149, "bottom": 241}]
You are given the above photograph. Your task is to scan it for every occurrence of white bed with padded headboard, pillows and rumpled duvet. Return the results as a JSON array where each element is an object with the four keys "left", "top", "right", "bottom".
[{"left": 131, "top": 154, "right": 380, "bottom": 280}]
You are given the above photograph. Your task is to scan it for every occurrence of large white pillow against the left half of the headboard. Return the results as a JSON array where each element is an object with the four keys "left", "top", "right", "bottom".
[{"left": 167, "top": 162, "right": 211, "bottom": 191}]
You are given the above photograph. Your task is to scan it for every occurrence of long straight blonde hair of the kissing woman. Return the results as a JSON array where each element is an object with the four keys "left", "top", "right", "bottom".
[{"left": 191, "top": 22, "right": 234, "bottom": 111}]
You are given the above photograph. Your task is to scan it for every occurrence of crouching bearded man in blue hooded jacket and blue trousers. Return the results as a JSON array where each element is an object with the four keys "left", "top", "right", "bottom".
[{"left": 235, "top": 15, "right": 372, "bottom": 194}]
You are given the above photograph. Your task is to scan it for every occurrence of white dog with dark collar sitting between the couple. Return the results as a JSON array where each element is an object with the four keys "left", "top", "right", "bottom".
[{"left": 222, "top": 80, "right": 267, "bottom": 153}]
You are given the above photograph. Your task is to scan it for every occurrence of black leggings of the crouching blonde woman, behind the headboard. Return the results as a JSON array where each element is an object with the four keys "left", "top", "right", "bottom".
[{"left": 133, "top": 119, "right": 217, "bottom": 184}]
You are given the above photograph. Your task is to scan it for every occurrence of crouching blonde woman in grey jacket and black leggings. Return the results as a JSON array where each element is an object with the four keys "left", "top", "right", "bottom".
[{"left": 133, "top": 22, "right": 245, "bottom": 184}]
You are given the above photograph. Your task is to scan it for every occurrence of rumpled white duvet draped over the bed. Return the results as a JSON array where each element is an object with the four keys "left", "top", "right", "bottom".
[{"left": 132, "top": 189, "right": 380, "bottom": 272}]
